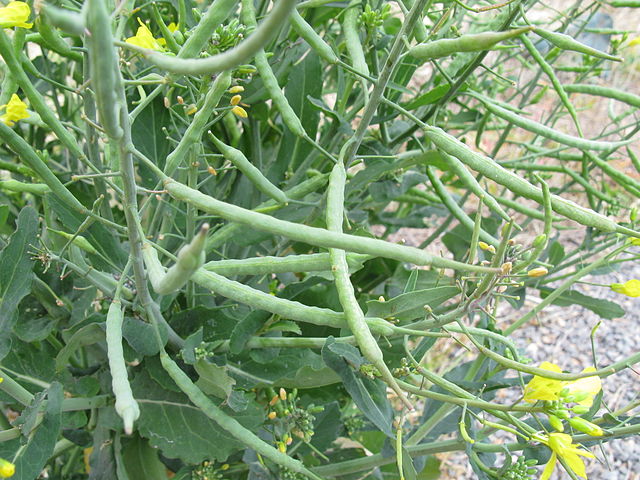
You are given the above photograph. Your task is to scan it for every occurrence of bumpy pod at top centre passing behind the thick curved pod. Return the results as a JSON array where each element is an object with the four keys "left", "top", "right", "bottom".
[{"left": 242, "top": 0, "right": 307, "bottom": 138}]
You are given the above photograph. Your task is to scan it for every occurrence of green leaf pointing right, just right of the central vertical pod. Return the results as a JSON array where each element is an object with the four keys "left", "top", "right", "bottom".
[{"left": 367, "top": 287, "right": 460, "bottom": 322}]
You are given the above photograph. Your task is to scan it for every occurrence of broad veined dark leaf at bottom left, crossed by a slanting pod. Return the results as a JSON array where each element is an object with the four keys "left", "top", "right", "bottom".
[{"left": 131, "top": 371, "right": 264, "bottom": 464}]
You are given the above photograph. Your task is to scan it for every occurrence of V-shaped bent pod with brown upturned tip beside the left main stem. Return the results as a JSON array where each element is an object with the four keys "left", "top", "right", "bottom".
[{"left": 142, "top": 224, "right": 209, "bottom": 295}]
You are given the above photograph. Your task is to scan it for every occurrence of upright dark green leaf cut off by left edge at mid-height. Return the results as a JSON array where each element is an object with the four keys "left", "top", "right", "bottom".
[{"left": 0, "top": 207, "right": 38, "bottom": 338}]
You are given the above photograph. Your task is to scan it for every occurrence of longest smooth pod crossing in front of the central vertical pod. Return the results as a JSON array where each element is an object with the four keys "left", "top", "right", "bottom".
[{"left": 164, "top": 179, "right": 500, "bottom": 272}]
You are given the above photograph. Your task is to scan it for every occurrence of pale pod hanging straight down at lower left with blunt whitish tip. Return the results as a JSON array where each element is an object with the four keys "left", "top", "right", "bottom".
[{"left": 106, "top": 298, "right": 140, "bottom": 435}]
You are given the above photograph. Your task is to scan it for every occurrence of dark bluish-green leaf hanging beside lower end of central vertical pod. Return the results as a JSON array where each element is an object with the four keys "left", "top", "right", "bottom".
[{"left": 322, "top": 337, "right": 395, "bottom": 437}]
